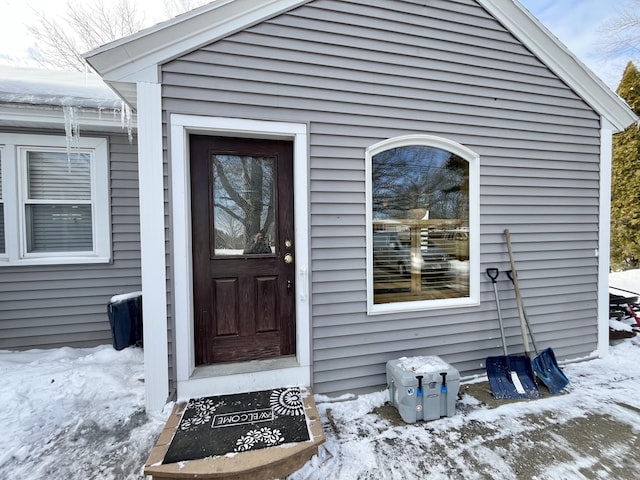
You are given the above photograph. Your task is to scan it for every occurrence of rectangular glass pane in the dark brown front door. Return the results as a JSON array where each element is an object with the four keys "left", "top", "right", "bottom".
[{"left": 212, "top": 154, "right": 276, "bottom": 255}]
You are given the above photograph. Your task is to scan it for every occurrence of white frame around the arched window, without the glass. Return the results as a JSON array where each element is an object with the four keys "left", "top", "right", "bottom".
[{"left": 365, "top": 135, "right": 480, "bottom": 315}]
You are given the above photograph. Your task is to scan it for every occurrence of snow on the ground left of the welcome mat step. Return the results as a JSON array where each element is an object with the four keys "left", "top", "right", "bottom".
[{"left": 0, "top": 346, "right": 164, "bottom": 480}]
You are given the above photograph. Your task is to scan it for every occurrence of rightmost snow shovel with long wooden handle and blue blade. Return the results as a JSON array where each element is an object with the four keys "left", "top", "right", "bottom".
[{"left": 504, "top": 229, "right": 569, "bottom": 395}]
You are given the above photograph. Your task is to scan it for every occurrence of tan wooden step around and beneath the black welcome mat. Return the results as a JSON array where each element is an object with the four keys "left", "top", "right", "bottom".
[{"left": 144, "top": 387, "right": 325, "bottom": 480}]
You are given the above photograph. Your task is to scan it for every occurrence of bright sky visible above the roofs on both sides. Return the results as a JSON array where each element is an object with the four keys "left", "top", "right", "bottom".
[{"left": 0, "top": 0, "right": 629, "bottom": 90}]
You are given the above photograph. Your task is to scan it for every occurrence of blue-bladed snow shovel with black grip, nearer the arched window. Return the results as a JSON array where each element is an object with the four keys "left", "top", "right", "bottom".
[{"left": 485, "top": 268, "right": 540, "bottom": 399}]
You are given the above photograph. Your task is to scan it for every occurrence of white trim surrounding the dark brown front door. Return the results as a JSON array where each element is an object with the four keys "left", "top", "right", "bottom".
[{"left": 170, "top": 114, "right": 311, "bottom": 400}]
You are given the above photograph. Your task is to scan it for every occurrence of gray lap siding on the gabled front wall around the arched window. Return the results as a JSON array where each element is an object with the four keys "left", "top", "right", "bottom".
[{"left": 162, "top": 0, "right": 600, "bottom": 393}]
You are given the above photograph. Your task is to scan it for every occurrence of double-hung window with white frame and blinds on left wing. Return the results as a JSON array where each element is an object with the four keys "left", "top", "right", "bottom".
[{"left": 0, "top": 134, "right": 111, "bottom": 265}]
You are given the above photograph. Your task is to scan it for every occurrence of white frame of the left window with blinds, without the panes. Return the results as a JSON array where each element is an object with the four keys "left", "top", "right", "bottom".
[{"left": 0, "top": 133, "right": 111, "bottom": 266}]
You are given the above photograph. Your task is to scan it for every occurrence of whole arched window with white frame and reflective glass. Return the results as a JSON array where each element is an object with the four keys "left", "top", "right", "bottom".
[{"left": 366, "top": 135, "right": 479, "bottom": 313}]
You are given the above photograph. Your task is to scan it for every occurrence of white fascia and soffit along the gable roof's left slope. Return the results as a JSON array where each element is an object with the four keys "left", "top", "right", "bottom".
[{"left": 84, "top": 0, "right": 310, "bottom": 81}]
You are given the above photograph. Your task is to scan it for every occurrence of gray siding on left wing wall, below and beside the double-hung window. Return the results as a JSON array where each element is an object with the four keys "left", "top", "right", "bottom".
[{"left": 0, "top": 131, "right": 141, "bottom": 349}]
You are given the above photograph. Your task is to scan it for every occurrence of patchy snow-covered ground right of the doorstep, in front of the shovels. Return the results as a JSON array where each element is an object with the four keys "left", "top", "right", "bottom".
[{"left": 291, "top": 339, "right": 640, "bottom": 480}]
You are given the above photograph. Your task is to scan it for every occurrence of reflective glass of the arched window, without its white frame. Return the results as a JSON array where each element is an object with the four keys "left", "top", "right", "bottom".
[{"left": 371, "top": 145, "right": 469, "bottom": 304}]
